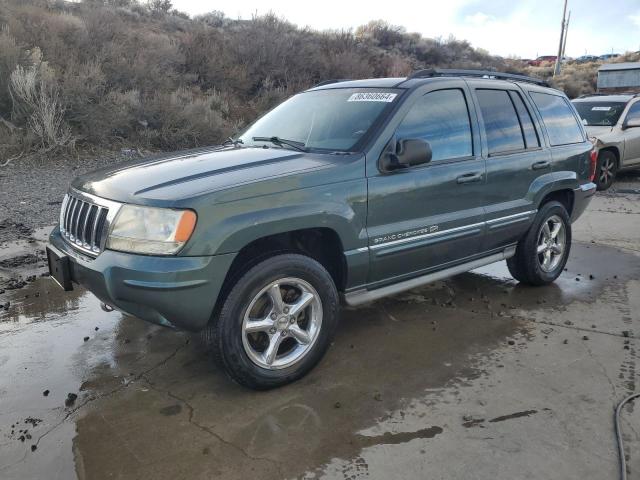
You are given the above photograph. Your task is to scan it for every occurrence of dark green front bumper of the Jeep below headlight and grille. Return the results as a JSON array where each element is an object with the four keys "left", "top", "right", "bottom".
[{"left": 49, "top": 227, "right": 235, "bottom": 331}]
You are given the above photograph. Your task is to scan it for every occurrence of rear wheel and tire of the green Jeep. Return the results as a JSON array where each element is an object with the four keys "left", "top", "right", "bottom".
[{"left": 507, "top": 201, "right": 571, "bottom": 285}]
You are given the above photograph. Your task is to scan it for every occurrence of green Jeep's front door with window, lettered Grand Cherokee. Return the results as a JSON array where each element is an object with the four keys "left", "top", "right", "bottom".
[{"left": 367, "top": 86, "right": 485, "bottom": 287}]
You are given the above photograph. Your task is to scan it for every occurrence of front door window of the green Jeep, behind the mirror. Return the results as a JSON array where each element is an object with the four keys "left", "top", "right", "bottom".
[{"left": 396, "top": 89, "right": 473, "bottom": 161}]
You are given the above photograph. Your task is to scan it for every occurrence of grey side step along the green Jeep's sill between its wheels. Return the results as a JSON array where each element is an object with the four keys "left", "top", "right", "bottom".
[{"left": 343, "top": 245, "right": 516, "bottom": 307}]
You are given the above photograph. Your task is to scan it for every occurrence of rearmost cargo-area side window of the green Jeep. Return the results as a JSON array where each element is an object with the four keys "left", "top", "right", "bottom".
[{"left": 530, "top": 92, "right": 584, "bottom": 146}]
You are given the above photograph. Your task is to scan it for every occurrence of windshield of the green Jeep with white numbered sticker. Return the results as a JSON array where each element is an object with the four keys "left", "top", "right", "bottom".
[{"left": 240, "top": 88, "right": 400, "bottom": 151}]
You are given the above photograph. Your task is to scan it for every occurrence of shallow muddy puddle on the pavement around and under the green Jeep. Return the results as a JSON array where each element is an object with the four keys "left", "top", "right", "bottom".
[{"left": 0, "top": 245, "right": 638, "bottom": 479}]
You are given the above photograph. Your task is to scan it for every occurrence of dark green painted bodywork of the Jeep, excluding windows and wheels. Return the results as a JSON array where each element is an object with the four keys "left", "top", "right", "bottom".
[{"left": 50, "top": 78, "right": 594, "bottom": 330}]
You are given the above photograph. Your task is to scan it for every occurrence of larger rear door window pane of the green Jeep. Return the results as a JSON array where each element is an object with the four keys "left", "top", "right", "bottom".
[{"left": 476, "top": 90, "right": 525, "bottom": 155}]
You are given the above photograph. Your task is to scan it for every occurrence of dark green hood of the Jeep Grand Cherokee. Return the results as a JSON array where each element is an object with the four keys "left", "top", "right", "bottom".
[{"left": 72, "top": 146, "right": 344, "bottom": 204}]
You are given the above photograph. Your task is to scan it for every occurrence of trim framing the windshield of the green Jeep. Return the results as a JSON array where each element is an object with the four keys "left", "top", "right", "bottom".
[{"left": 234, "top": 84, "right": 407, "bottom": 155}]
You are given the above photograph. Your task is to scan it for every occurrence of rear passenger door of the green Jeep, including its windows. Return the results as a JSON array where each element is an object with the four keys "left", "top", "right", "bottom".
[{"left": 469, "top": 80, "right": 552, "bottom": 251}]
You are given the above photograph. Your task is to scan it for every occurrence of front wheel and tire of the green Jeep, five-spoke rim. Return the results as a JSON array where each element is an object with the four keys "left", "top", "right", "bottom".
[{"left": 207, "top": 254, "right": 338, "bottom": 390}]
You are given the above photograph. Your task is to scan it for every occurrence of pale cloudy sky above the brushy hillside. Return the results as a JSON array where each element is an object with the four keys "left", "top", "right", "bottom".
[{"left": 173, "top": 0, "right": 640, "bottom": 58}]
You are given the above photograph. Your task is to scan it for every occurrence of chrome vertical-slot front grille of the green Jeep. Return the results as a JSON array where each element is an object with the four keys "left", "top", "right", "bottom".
[{"left": 60, "top": 194, "right": 109, "bottom": 255}]
